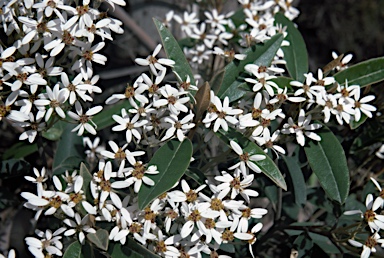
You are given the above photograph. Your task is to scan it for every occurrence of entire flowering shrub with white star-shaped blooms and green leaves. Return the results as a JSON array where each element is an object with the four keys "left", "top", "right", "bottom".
[{"left": 0, "top": 0, "right": 384, "bottom": 257}]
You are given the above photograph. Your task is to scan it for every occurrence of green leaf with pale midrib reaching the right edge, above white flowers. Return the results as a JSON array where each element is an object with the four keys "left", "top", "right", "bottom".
[{"left": 333, "top": 57, "right": 384, "bottom": 87}]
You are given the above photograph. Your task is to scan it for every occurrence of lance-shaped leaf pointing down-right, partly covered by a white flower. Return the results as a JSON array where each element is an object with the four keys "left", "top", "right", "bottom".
[{"left": 216, "top": 128, "right": 287, "bottom": 190}]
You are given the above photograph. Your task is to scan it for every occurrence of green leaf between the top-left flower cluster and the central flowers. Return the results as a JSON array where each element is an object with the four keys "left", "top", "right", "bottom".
[{"left": 92, "top": 99, "right": 132, "bottom": 130}]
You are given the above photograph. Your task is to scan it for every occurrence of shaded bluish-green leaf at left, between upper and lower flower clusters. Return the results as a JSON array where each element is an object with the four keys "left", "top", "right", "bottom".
[{"left": 52, "top": 124, "right": 85, "bottom": 175}]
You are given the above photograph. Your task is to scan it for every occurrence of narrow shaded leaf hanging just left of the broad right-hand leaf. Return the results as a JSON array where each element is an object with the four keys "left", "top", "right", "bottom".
[{"left": 282, "top": 156, "right": 307, "bottom": 205}]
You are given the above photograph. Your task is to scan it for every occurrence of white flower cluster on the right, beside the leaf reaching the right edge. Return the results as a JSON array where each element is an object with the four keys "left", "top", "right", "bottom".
[{"left": 239, "top": 61, "right": 376, "bottom": 148}]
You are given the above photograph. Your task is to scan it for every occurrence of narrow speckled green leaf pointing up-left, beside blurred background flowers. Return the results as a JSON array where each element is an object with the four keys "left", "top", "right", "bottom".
[{"left": 153, "top": 18, "right": 196, "bottom": 85}]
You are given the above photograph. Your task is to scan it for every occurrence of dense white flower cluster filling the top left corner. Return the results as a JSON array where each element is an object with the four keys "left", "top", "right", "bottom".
[{"left": 0, "top": 0, "right": 125, "bottom": 142}]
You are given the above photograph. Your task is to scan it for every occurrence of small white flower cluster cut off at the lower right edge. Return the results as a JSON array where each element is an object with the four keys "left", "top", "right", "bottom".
[{"left": 344, "top": 177, "right": 384, "bottom": 258}]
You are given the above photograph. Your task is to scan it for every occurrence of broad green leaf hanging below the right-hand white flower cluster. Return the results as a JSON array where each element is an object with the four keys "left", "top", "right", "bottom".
[{"left": 304, "top": 125, "right": 350, "bottom": 203}]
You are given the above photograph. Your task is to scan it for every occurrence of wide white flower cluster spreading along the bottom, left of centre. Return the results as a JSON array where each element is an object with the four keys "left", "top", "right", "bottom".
[{"left": 21, "top": 152, "right": 267, "bottom": 257}]
